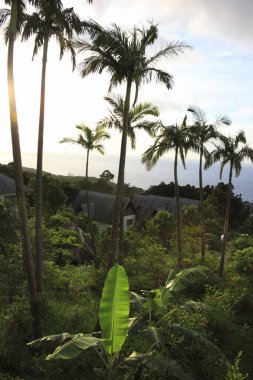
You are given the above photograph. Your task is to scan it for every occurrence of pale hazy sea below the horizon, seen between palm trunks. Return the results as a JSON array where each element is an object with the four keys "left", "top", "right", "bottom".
[{"left": 0, "top": 153, "right": 253, "bottom": 202}]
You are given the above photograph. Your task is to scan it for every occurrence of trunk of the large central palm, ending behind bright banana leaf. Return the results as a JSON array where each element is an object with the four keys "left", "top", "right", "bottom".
[{"left": 107, "top": 78, "right": 132, "bottom": 270}]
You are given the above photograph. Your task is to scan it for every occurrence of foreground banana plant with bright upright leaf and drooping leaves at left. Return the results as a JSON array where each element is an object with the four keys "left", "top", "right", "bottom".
[{"left": 28, "top": 265, "right": 130, "bottom": 380}]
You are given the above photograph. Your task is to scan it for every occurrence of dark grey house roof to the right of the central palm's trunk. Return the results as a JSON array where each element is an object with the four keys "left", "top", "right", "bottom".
[{"left": 131, "top": 194, "right": 199, "bottom": 217}]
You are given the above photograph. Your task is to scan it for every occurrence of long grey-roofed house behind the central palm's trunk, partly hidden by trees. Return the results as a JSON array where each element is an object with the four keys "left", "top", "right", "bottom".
[{"left": 71, "top": 190, "right": 200, "bottom": 230}]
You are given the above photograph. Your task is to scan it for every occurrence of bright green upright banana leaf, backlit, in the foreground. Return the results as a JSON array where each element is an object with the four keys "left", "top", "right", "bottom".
[{"left": 99, "top": 265, "right": 130, "bottom": 354}]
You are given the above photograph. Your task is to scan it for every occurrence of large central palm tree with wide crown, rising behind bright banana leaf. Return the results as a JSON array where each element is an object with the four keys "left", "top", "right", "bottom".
[{"left": 75, "top": 21, "right": 188, "bottom": 268}]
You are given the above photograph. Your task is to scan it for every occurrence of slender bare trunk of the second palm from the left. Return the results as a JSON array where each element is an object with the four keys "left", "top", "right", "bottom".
[{"left": 35, "top": 37, "right": 48, "bottom": 292}]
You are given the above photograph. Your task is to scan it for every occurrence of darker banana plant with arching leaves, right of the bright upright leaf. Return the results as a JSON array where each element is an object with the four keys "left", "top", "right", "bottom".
[{"left": 128, "top": 267, "right": 225, "bottom": 380}]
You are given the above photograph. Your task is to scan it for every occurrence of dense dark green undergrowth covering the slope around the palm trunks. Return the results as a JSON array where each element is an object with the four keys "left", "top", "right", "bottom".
[{"left": 0, "top": 165, "right": 253, "bottom": 379}]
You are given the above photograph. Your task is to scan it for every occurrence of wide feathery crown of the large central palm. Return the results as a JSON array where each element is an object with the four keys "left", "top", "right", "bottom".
[{"left": 75, "top": 21, "right": 188, "bottom": 101}]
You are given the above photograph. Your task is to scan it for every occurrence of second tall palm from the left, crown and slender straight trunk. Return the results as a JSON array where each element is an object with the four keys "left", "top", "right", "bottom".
[{"left": 22, "top": 0, "right": 82, "bottom": 292}]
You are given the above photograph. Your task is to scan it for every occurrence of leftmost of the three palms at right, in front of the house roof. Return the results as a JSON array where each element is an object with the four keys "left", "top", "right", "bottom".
[{"left": 142, "top": 116, "right": 190, "bottom": 267}]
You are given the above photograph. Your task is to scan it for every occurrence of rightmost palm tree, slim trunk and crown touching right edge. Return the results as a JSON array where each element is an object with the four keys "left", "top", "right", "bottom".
[{"left": 205, "top": 131, "right": 253, "bottom": 277}]
